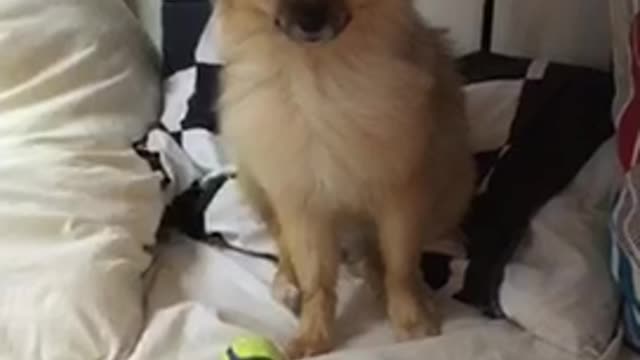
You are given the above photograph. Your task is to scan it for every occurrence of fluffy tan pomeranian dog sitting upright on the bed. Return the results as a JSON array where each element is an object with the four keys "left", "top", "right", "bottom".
[{"left": 215, "top": 0, "right": 474, "bottom": 358}]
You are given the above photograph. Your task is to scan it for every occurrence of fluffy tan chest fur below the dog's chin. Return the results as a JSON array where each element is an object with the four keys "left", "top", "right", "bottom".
[{"left": 221, "top": 30, "right": 430, "bottom": 206}]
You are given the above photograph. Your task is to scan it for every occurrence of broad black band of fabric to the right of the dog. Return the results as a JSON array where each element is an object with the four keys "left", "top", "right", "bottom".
[{"left": 442, "top": 52, "right": 613, "bottom": 317}]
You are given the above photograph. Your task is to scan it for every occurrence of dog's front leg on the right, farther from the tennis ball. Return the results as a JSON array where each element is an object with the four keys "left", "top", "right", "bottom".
[{"left": 378, "top": 191, "right": 441, "bottom": 340}]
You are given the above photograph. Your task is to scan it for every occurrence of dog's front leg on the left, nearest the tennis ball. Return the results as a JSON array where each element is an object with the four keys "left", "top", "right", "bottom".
[{"left": 278, "top": 209, "right": 339, "bottom": 359}]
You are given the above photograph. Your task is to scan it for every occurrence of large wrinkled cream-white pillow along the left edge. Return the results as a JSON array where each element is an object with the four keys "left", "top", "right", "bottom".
[{"left": 0, "top": 0, "right": 163, "bottom": 360}]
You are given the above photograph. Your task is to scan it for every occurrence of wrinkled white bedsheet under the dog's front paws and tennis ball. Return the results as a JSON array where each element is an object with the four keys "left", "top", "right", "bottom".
[{"left": 130, "top": 235, "right": 627, "bottom": 360}]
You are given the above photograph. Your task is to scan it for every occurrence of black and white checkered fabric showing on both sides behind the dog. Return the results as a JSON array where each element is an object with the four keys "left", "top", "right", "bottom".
[{"left": 141, "top": 0, "right": 612, "bottom": 324}]
